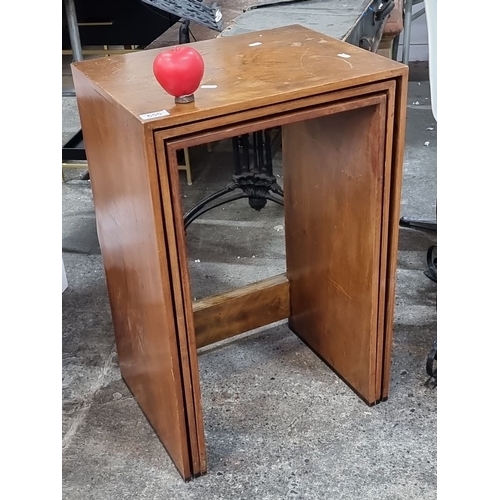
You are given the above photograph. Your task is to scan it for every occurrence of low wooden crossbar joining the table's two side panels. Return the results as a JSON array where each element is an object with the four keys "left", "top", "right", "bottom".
[{"left": 193, "top": 274, "right": 290, "bottom": 347}]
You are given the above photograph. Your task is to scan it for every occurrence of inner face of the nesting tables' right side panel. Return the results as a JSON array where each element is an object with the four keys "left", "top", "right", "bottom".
[{"left": 283, "top": 95, "right": 387, "bottom": 403}]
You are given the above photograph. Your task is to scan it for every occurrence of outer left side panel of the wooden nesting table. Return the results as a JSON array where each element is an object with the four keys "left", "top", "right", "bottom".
[{"left": 73, "top": 71, "right": 199, "bottom": 478}]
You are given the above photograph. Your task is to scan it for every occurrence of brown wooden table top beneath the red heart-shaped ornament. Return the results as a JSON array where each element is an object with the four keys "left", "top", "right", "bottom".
[{"left": 72, "top": 25, "right": 407, "bottom": 128}]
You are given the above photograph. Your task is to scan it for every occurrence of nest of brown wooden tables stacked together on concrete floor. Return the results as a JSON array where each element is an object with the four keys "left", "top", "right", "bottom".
[{"left": 72, "top": 25, "right": 407, "bottom": 480}]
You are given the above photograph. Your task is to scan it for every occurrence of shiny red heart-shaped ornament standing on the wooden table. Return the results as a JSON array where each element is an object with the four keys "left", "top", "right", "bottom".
[{"left": 153, "top": 45, "right": 205, "bottom": 103}]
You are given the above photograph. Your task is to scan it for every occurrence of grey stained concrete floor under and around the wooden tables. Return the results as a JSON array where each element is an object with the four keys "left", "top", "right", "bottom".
[{"left": 62, "top": 52, "right": 437, "bottom": 494}]
